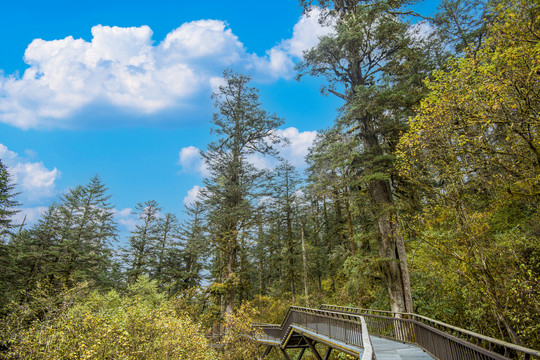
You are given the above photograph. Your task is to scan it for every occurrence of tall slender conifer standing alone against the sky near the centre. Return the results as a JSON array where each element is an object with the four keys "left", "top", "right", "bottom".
[{"left": 202, "top": 70, "right": 282, "bottom": 314}]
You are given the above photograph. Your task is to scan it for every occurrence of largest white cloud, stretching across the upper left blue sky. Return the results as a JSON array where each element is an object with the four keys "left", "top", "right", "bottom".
[{"left": 0, "top": 9, "right": 330, "bottom": 129}]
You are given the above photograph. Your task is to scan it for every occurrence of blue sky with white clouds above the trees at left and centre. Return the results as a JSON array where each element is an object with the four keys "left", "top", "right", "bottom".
[{"left": 0, "top": 0, "right": 437, "bottom": 232}]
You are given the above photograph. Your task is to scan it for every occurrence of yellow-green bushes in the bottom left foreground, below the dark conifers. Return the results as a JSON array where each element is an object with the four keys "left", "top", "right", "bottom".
[{"left": 6, "top": 278, "right": 218, "bottom": 360}]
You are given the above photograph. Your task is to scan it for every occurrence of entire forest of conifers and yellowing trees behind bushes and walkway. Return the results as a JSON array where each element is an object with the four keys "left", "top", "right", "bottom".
[{"left": 0, "top": 0, "right": 540, "bottom": 358}]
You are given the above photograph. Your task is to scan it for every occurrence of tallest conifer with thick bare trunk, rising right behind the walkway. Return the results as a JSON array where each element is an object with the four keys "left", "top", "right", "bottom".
[{"left": 298, "top": 0, "right": 440, "bottom": 312}]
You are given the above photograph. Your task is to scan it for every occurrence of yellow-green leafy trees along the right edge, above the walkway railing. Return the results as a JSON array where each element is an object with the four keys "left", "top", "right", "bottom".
[{"left": 398, "top": 0, "right": 540, "bottom": 347}]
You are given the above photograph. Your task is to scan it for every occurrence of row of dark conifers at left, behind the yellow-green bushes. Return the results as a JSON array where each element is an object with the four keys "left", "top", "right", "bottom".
[{"left": 0, "top": 174, "right": 205, "bottom": 315}]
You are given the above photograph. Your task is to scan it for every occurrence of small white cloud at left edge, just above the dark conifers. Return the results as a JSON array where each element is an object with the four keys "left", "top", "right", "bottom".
[{"left": 0, "top": 144, "right": 60, "bottom": 202}]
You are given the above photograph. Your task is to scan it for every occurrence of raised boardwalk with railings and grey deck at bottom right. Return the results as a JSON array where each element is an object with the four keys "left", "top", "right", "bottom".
[{"left": 254, "top": 305, "right": 540, "bottom": 360}]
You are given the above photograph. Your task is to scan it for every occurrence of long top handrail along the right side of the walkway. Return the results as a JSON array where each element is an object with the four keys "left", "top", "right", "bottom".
[{"left": 320, "top": 304, "right": 540, "bottom": 358}]
